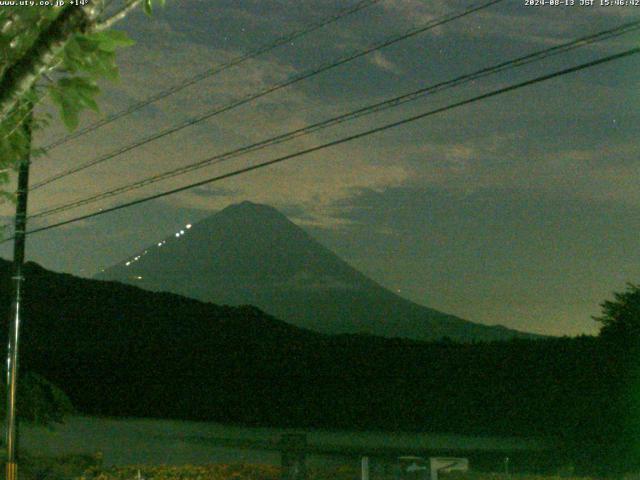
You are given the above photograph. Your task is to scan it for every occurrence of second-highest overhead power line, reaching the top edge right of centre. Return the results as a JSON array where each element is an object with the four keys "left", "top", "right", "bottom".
[{"left": 31, "top": 0, "right": 504, "bottom": 191}]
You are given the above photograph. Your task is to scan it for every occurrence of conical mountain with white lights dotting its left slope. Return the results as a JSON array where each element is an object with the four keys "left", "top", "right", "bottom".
[{"left": 95, "top": 202, "right": 533, "bottom": 341}]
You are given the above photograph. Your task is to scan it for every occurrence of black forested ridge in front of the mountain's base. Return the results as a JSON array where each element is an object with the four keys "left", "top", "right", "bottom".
[{"left": 0, "top": 262, "right": 637, "bottom": 469}]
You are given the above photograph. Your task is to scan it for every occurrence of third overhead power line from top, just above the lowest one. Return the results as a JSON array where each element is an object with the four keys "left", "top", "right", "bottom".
[{"left": 29, "top": 20, "right": 640, "bottom": 219}]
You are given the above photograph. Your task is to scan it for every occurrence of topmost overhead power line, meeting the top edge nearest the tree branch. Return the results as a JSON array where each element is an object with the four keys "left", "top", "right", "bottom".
[{"left": 44, "top": 0, "right": 381, "bottom": 151}]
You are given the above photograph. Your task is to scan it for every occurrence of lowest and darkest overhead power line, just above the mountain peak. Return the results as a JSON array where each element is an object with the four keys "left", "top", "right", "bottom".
[{"left": 12, "top": 47, "right": 640, "bottom": 241}]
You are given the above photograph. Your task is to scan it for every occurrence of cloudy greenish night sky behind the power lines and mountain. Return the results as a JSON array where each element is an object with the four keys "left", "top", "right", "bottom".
[{"left": 0, "top": 0, "right": 640, "bottom": 335}]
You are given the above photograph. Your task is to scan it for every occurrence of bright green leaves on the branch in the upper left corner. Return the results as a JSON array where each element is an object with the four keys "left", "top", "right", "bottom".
[{"left": 0, "top": 0, "right": 164, "bottom": 198}]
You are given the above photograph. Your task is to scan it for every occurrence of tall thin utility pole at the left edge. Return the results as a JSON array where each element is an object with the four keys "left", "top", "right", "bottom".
[{"left": 5, "top": 102, "right": 33, "bottom": 480}]
